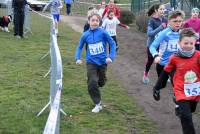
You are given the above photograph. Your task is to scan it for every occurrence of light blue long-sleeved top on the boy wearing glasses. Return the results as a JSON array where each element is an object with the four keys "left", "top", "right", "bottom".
[{"left": 149, "top": 26, "right": 179, "bottom": 66}]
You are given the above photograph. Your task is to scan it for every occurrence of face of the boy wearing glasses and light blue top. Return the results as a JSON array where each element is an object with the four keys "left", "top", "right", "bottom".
[{"left": 168, "top": 16, "right": 183, "bottom": 31}]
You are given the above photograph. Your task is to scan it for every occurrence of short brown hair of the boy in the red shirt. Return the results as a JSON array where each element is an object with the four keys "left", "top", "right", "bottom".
[{"left": 179, "top": 28, "right": 197, "bottom": 41}]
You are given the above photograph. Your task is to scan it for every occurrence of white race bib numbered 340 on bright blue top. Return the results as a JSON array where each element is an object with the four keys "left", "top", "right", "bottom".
[{"left": 88, "top": 42, "right": 104, "bottom": 55}]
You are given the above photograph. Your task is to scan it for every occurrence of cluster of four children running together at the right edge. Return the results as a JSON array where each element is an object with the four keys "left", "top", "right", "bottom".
[{"left": 142, "top": 4, "right": 200, "bottom": 134}]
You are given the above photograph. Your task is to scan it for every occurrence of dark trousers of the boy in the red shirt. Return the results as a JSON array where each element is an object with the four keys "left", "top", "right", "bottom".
[{"left": 176, "top": 100, "right": 198, "bottom": 134}]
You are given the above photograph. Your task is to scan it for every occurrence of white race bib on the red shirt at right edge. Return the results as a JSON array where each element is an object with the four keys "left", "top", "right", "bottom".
[{"left": 184, "top": 82, "right": 200, "bottom": 97}]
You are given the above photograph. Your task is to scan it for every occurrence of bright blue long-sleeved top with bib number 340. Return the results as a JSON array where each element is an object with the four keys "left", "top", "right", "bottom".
[{"left": 75, "top": 28, "right": 116, "bottom": 65}]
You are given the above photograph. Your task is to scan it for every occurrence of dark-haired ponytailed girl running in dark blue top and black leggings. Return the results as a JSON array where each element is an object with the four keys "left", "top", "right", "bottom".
[{"left": 142, "top": 4, "right": 167, "bottom": 84}]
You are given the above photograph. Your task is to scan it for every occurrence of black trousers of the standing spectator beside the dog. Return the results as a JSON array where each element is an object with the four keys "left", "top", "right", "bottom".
[{"left": 14, "top": 12, "right": 24, "bottom": 37}]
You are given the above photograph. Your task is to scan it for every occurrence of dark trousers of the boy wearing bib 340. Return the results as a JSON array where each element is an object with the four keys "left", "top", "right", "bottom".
[{"left": 86, "top": 63, "right": 107, "bottom": 104}]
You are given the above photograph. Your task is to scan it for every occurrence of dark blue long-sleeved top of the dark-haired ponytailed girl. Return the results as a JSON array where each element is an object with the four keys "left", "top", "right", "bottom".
[{"left": 147, "top": 17, "right": 167, "bottom": 47}]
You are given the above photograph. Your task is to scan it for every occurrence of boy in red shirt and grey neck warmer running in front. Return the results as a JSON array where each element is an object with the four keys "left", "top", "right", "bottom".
[{"left": 153, "top": 29, "right": 200, "bottom": 134}]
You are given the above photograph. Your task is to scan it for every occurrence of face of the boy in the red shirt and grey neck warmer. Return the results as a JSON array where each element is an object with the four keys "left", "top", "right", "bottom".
[{"left": 179, "top": 37, "right": 196, "bottom": 51}]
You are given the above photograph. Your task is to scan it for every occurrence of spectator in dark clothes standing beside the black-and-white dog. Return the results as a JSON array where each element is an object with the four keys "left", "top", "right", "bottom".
[{"left": 12, "top": 0, "right": 28, "bottom": 39}]
